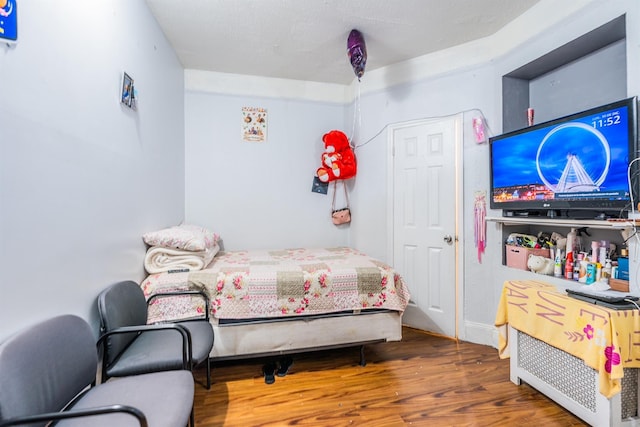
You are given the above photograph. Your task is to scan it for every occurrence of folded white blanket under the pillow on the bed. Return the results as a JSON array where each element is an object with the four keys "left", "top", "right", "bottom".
[{"left": 144, "top": 244, "right": 220, "bottom": 274}]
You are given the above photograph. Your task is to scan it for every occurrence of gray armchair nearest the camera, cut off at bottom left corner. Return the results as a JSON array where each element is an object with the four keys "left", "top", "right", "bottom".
[{"left": 0, "top": 315, "right": 194, "bottom": 427}]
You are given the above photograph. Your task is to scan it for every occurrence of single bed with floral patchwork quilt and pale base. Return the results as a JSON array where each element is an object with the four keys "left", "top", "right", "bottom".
[{"left": 141, "top": 247, "right": 409, "bottom": 364}]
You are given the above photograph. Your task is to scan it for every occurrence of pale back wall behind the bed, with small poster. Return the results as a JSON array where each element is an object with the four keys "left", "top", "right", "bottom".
[{"left": 185, "top": 91, "right": 349, "bottom": 250}]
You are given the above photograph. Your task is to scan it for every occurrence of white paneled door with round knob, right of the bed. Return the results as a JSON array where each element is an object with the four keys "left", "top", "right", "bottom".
[{"left": 389, "top": 115, "right": 462, "bottom": 337}]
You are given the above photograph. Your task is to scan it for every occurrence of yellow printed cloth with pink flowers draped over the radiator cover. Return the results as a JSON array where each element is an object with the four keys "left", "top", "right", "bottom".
[{"left": 495, "top": 280, "right": 640, "bottom": 398}]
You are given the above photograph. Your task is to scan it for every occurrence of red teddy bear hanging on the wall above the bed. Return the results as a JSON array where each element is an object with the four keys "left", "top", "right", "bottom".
[{"left": 316, "top": 130, "right": 357, "bottom": 182}]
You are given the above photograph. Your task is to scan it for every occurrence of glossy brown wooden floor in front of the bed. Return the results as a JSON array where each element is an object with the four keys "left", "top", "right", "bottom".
[{"left": 195, "top": 328, "right": 586, "bottom": 427}]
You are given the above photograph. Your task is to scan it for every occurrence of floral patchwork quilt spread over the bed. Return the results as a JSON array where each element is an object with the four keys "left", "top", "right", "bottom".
[{"left": 141, "top": 247, "right": 409, "bottom": 323}]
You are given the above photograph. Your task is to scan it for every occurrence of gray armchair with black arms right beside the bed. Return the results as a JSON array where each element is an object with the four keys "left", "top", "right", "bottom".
[{"left": 98, "top": 281, "right": 214, "bottom": 389}]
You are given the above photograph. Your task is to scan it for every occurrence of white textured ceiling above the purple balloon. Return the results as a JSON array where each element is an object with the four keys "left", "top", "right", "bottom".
[{"left": 146, "top": 0, "right": 539, "bottom": 85}]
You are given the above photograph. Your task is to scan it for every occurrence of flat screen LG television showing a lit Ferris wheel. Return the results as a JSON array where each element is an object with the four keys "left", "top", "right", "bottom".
[{"left": 489, "top": 97, "right": 638, "bottom": 219}]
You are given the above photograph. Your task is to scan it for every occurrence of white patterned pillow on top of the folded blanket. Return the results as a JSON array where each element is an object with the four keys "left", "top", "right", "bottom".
[{"left": 142, "top": 224, "right": 219, "bottom": 252}]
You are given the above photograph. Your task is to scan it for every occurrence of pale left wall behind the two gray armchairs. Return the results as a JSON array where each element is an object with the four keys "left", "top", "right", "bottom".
[{"left": 0, "top": 0, "right": 184, "bottom": 340}]
